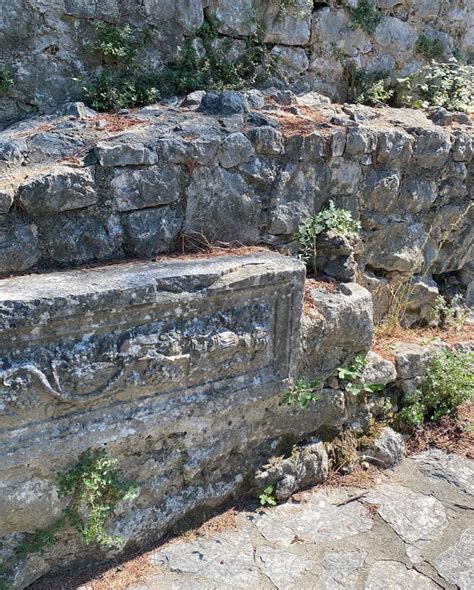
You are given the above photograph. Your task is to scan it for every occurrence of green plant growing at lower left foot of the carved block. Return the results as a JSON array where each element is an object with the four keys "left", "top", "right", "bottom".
[{"left": 0, "top": 449, "right": 138, "bottom": 590}]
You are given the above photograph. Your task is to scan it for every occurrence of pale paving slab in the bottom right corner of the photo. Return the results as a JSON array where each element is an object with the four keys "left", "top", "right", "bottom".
[{"left": 434, "top": 527, "right": 474, "bottom": 590}]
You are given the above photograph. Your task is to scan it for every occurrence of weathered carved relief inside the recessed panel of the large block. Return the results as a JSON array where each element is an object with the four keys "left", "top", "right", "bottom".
[{"left": 0, "top": 304, "right": 271, "bottom": 426}]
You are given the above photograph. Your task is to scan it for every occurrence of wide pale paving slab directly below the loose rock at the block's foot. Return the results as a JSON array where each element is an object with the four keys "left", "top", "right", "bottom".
[{"left": 254, "top": 494, "right": 373, "bottom": 546}]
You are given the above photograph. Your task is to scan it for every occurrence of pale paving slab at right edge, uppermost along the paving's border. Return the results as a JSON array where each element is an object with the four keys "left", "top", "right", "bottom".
[{"left": 414, "top": 449, "right": 474, "bottom": 495}]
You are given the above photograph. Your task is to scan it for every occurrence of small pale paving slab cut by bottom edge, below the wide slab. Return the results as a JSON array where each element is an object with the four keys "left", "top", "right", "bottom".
[{"left": 255, "top": 547, "right": 313, "bottom": 590}]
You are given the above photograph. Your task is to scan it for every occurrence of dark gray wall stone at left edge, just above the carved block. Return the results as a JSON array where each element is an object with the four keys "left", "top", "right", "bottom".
[{"left": 0, "top": 217, "right": 41, "bottom": 274}]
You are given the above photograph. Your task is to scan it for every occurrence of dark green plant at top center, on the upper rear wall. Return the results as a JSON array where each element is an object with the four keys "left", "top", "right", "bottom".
[{"left": 159, "top": 19, "right": 276, "bottom": 94}]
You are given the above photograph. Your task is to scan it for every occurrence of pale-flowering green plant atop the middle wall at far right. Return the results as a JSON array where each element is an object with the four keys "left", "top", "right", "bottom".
[{"left": 396, "top": 58, "right": 474, "bottom": 112}]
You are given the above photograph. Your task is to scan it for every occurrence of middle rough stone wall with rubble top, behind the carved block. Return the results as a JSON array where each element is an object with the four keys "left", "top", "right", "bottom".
[{"left": 0, "top": 90, "right": 474, "bottom": 324}]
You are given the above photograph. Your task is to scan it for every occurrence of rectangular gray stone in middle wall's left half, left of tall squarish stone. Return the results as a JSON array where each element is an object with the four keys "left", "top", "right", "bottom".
[{"left": 110, "top": 165, "right": 183, "bottom": 211}]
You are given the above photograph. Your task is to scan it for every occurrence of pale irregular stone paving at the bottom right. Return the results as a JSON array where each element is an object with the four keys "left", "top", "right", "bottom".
[{"left": 81, "top": 449, "right": 474, "bottom": 590}]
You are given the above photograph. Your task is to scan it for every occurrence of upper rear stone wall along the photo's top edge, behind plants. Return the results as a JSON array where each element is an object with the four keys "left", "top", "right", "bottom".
[{"left": 0, "top": 0, "right": 474, "bottom": 125}]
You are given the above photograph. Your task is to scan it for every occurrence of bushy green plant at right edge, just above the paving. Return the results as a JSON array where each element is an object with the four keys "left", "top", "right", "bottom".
[{"left": 397, "top": 349, "right": 474, "bottom": 429}]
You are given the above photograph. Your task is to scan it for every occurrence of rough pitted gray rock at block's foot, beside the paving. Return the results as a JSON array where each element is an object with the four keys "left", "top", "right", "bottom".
[{"left": 255, "top": 441, "right": 329, "bottom": 500}]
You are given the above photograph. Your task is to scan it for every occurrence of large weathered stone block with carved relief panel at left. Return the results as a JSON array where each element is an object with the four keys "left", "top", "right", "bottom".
[{"left": 0, "top": 252, "right": 324, "bottom": 585}]
